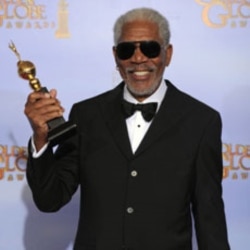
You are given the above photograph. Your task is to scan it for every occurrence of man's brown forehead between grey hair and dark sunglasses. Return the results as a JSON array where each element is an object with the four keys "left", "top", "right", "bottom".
[{"left": 119, "top": 21, "right": 161, "bottom": 42}]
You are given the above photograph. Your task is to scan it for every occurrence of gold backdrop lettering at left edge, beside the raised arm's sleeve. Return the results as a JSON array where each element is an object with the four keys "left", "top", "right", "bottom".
[{"left": 0, "top": 145, "right": 27, "bottom": 181}]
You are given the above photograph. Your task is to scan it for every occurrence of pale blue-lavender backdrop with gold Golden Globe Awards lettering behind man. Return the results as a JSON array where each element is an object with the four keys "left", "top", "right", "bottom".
[{"left": 0, "top": 0, "right": 250, "bottom": 250}]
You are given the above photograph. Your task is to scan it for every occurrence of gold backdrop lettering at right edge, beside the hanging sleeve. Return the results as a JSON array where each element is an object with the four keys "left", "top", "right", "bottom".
[{"left": 222, "top": 143, "right": 250, "bottom": 180}]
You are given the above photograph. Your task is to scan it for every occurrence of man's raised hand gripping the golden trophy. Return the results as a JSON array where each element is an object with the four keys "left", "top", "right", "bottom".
[{"left": 24, "top": 89, "right": 64, "bottom": 151}]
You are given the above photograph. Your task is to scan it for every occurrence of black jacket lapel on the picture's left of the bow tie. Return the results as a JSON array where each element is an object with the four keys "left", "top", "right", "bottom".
[{"left": 100, "top": 83, "right": 132, "bottom": 158}]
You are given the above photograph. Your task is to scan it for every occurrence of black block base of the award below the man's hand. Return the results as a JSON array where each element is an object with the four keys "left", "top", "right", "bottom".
[{"left": 48, "top": 117, "right": 77, "bottom": 146}]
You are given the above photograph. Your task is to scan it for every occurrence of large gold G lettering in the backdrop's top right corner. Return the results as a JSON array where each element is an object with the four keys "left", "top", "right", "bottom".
[{"left": 195, "top": 0, "right": 250, "bottom": 28}]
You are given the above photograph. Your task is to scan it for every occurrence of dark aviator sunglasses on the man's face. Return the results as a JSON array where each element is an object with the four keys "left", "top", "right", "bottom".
[{"left": 116, "top": 41, "right": 161, "bottom": 60}]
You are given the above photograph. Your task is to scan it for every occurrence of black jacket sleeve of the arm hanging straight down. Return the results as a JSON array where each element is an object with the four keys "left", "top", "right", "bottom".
[{"left": 193, "top": 112, "right": 230, "bottom": 250}]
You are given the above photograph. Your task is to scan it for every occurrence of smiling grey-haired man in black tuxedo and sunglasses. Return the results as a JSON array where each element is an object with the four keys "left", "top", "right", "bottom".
[{"left": 25, "top": 8, "right": 229, "bottom": 250}]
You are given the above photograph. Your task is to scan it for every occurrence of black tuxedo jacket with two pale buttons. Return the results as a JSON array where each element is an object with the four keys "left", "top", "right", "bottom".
[{"left": 27, "top": 81, "right": 229, "bottom": 250}]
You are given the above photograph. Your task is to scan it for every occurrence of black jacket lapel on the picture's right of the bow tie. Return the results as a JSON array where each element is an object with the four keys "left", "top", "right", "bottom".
[{"left": 135, "top": 81, "right": 186, "bottom": 156}]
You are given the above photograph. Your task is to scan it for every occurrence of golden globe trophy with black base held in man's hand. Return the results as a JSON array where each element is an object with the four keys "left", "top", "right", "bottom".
[{"left": 9, "top": 42, "right": 76, "bottom": 146}]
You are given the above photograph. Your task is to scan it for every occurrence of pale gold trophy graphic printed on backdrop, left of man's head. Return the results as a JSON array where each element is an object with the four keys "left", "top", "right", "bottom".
[{"left": 55, "top": 0, "right": 70, "bottom": 38}]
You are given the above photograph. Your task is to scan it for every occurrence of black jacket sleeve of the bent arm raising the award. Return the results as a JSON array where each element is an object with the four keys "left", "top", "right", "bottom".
[{"left": 26, "top": 104, "right": 79, "bottom": 212}]
